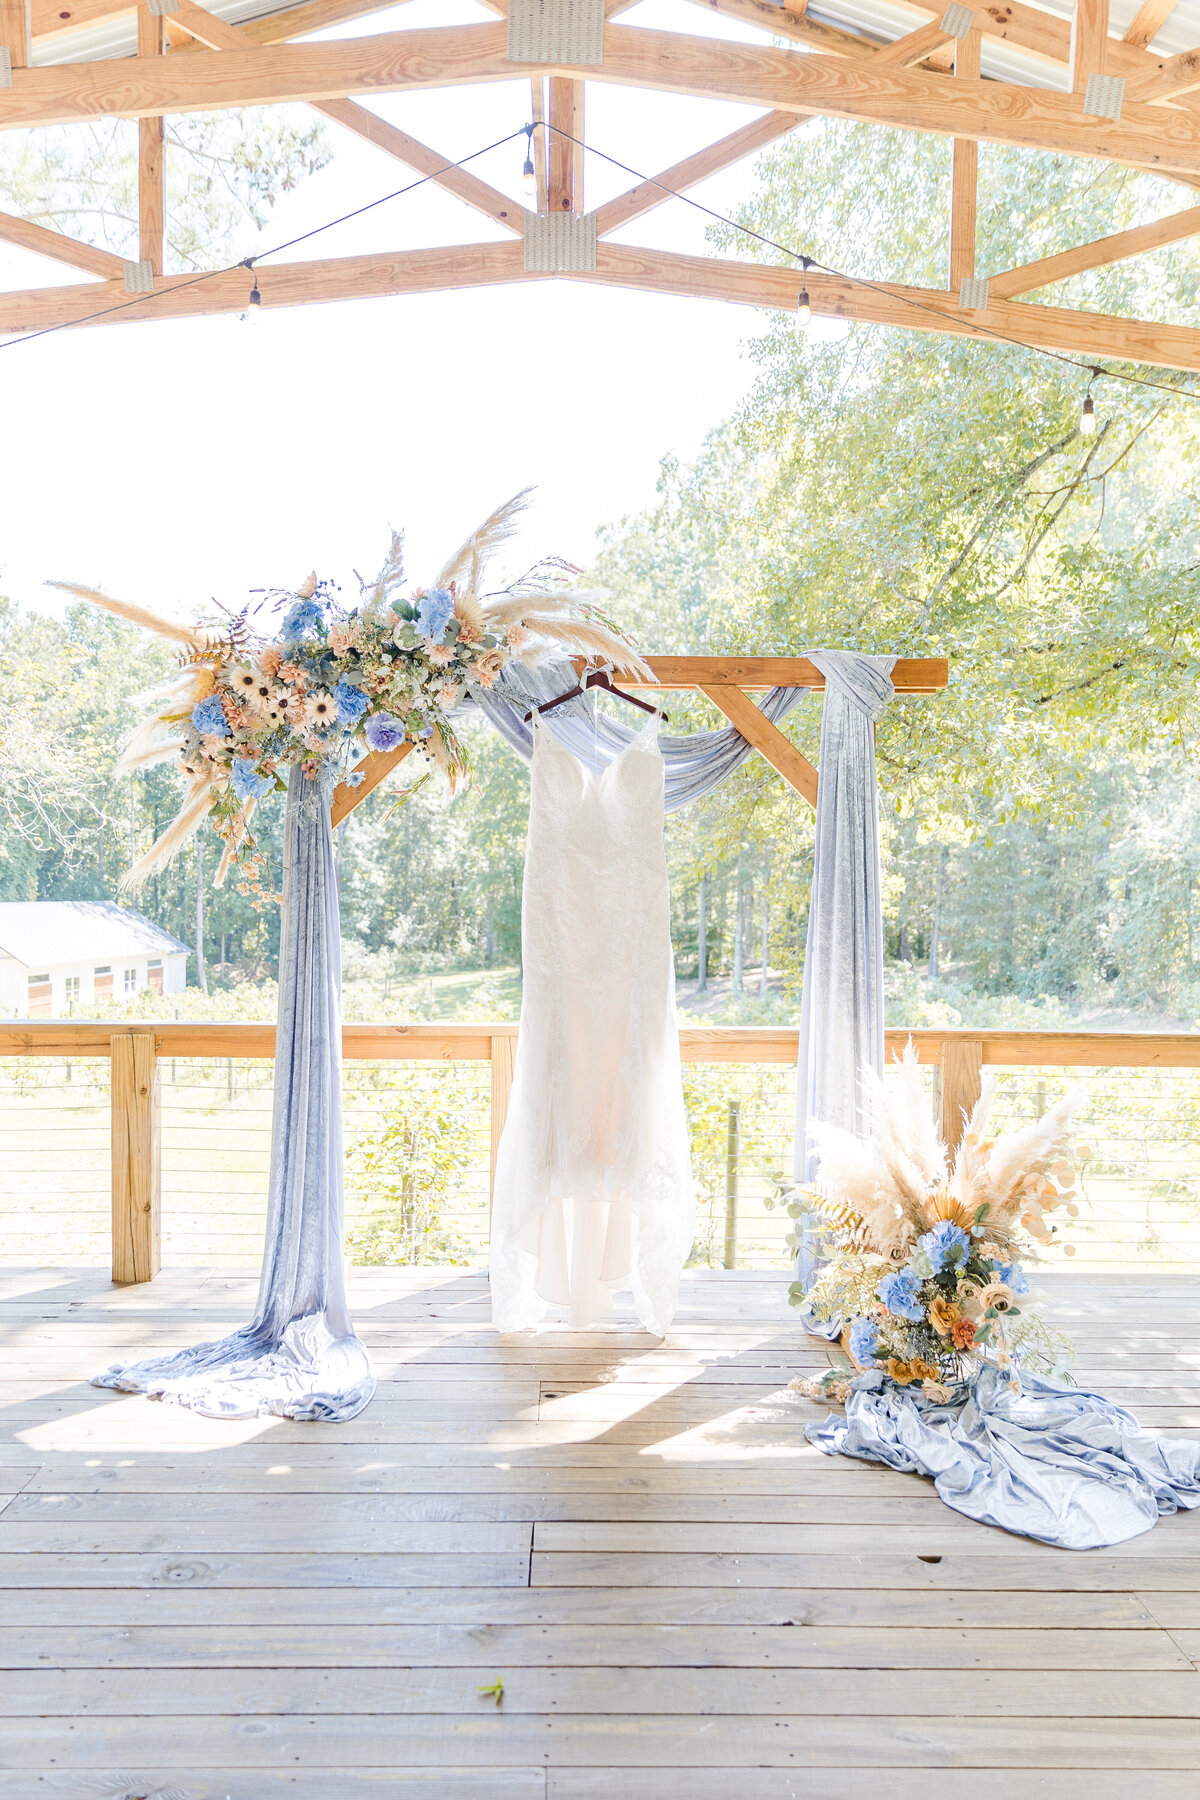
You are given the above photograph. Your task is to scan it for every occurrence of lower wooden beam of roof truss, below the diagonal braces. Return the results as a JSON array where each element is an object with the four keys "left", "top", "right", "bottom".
[{"left": 11, "top": 243, "right": 1200, "bottom": 374}]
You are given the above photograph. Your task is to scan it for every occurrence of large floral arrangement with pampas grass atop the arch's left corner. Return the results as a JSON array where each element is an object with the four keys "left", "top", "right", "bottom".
[{"left": 52, "top": 493, "right": 653, "bottom": 904}]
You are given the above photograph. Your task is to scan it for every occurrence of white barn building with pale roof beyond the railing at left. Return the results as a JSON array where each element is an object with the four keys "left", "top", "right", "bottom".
[{"left": 0, "top": 900, "right": 191, "bottom": 1019}]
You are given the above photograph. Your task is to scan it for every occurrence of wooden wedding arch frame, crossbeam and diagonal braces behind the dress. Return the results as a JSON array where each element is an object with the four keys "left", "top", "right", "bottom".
[{"left": 331, "top": 657, "right": 948, "bottom": 824}]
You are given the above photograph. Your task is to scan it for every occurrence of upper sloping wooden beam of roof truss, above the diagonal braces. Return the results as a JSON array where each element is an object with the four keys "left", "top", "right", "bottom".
[{"left": 0, "top": 25, "right": 1200, "bottom": 175}]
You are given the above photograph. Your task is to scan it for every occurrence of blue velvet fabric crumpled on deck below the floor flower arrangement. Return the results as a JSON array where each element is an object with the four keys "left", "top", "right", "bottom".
[{"left": 806, "top": 1363, "right": 1200, "bottom": 1550}]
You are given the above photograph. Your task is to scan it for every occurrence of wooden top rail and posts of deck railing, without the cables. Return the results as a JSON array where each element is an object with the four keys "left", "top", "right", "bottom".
[{"left": 0, "top": 1019, "right": 1200, "bottom": 1283}]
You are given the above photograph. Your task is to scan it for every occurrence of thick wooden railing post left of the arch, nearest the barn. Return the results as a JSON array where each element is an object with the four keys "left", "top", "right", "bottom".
[{"left": 112, "top": 1031, "right": 162, "bottom": 1283}]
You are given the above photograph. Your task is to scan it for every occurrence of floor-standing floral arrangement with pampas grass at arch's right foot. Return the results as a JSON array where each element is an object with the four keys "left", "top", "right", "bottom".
[{"left": 790, "top": 1048, "right": 1083, "bottom": 1402}]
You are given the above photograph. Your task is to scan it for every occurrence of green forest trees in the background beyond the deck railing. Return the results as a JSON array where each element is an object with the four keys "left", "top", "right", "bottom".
[{"left": 0, "top": 121, "right": 1200, "bottom": 1028}]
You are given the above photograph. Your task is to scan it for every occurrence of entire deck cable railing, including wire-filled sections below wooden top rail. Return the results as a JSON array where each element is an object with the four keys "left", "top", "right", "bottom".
[{"left": 0, "top": 1019, "right": 1200, "bottom": 1282}]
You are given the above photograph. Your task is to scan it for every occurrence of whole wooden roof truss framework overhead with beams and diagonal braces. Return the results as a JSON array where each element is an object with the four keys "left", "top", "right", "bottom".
[{"left": 0, "top": 0, "right": 1200, "bottom": 373}]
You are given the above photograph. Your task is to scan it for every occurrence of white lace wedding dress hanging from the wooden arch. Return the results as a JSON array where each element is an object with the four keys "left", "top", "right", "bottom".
[{"left": 491, "top": 720, "right": 693, "bottom": 1334}]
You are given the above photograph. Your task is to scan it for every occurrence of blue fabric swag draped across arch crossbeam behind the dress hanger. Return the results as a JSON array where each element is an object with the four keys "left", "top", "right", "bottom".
[{"left": 471, "top": 652, "right": 815, "bottom": 812}]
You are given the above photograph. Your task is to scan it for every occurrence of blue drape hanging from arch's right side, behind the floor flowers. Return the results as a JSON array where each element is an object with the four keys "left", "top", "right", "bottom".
[{"left": 795, "top": 650, "right": 896, "bottom": 1337}]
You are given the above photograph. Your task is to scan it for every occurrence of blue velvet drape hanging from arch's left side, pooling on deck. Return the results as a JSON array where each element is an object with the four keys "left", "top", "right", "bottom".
[{"left": 94, "top": 769, "right": 374, "bottom": 1420}]
